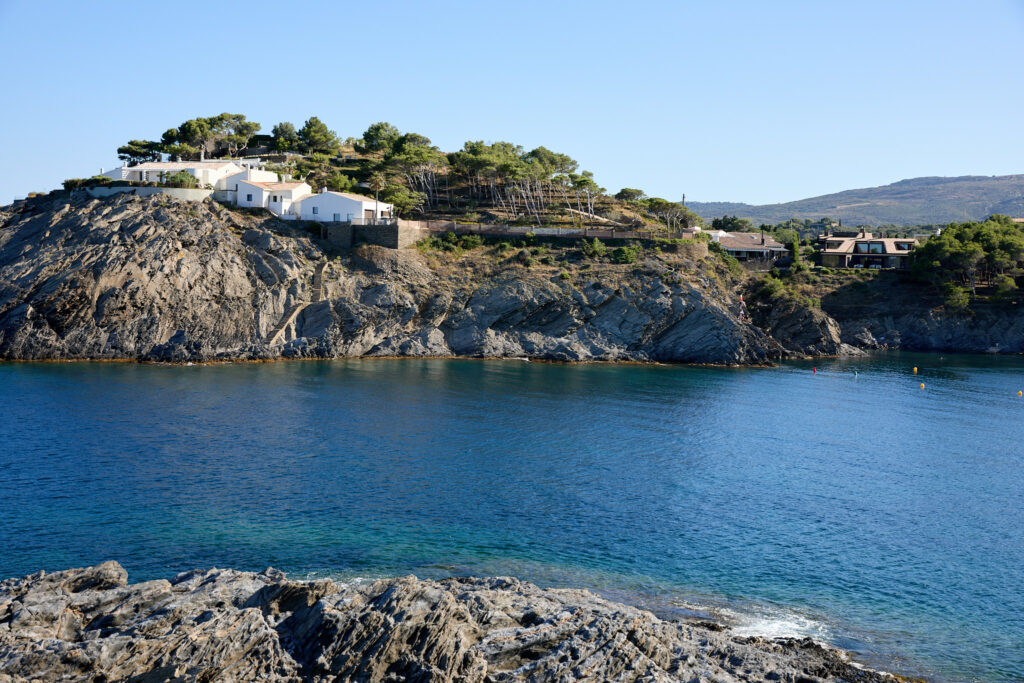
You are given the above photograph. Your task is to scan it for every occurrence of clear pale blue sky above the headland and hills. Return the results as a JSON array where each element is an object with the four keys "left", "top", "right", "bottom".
[{"left": 0, "top": 0, "right": 1024, "bottom": 204}]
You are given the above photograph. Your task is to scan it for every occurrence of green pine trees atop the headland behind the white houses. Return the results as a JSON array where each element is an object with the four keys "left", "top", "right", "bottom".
[{"left": 118, "top": 113, "right": 700, "bottom": 229}]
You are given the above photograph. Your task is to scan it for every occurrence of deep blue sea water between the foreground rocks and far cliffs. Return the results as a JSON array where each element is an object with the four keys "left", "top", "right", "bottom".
[{"left": 0, "top": 353, "right": 1024, "bottom": 681}]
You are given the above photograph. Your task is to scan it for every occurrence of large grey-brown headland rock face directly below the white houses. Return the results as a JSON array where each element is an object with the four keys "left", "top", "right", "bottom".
[{"left": 0, "top": 195, "right": 781, "bottom": 364}]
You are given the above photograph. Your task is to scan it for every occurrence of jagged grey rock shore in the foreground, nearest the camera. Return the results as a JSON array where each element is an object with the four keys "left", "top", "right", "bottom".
[{"left": 0, "top": 562, "right": 896, "bottom": 683}]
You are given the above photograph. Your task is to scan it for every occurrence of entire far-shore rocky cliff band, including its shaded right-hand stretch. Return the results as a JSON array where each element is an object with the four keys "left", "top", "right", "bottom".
[{"left": 0, "top": 195, "right": 1007, "bottom": 364}]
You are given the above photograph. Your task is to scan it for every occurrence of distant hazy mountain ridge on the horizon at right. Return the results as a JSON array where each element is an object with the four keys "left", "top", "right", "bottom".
[{"left": 687, "top": 175, "right": 1024, "bottom": 225}]
